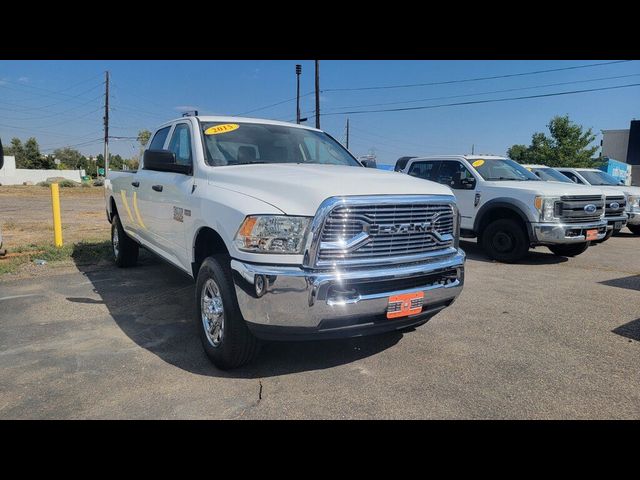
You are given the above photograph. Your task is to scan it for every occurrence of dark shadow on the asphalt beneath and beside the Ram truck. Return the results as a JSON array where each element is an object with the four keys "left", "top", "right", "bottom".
[{"left": 72, "top": 250, "right": 402, "bottom": 378}]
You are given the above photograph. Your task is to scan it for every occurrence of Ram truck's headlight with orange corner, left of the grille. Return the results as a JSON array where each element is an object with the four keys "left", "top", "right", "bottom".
[{"left": 234, "top": 215, "right": 311, "bottom": 254}]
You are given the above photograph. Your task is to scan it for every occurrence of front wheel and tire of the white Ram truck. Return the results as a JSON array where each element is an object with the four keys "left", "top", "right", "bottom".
[{"left": 196, "top": 256, "right": 260, "bottom": 370}]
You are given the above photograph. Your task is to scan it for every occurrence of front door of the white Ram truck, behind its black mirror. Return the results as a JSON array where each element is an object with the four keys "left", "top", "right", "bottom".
[{"left": 145, "top": 122, "right": 194, "bottom": 271}]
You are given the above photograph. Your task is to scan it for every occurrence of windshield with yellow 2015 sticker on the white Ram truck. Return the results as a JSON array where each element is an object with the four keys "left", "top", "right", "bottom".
[{"left": 201, "top": 122, "right": 362, "bottom": 167}]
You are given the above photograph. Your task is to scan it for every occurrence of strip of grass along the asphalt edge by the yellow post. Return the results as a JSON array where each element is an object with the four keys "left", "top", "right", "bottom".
[{"left": 0, "top": 240, "right": 111, "bottom": 275}]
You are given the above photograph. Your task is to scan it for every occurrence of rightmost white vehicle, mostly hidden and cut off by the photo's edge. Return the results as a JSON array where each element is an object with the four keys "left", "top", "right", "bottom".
[{"left": 556, "top": 167, "right": 640, "bottom": 235}]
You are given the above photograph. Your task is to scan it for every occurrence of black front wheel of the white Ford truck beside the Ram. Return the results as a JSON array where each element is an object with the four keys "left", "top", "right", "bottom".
[{"left": 480, "top": 218, "right": 529, "bottom": 263}]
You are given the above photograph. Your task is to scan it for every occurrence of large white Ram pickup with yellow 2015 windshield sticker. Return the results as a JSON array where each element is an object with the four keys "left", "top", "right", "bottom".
[{"left": 105, "top": 116, "right": 465, "bottom": 368}]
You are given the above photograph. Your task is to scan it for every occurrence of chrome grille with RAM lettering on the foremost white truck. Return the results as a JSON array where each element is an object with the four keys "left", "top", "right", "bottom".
[{"left": 316, "top": 201, "right": 456, "bottom": 266}]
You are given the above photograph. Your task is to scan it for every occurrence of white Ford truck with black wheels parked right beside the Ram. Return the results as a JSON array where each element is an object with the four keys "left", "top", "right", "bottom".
[{"left": 404, "top": 155, "right": 607, "bottom": 263}]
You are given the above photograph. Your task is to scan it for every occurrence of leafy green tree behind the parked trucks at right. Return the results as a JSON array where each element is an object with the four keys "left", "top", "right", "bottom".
[{"left": 507, "top": 115, "right": 602, "bottom": 167}]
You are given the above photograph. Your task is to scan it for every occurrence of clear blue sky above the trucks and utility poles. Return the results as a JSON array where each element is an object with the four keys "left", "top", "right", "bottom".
[{"left": 0, "top": 59, "right": 640, "bottom": 164}]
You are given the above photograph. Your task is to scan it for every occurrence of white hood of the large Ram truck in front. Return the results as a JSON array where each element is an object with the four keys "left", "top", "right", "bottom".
[{"left": 209, "top": 163, "right": 453, "bottom": 216}]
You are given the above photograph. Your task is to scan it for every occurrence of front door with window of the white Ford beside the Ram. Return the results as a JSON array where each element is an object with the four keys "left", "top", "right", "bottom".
[{"left": 434, "top": 160, "right": 478, "bottom": 230}]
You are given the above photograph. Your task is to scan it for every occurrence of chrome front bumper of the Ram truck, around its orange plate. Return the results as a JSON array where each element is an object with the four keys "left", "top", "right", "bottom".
[{"left": 231, "top": 250, "right": 465, "bottom": 339}]
